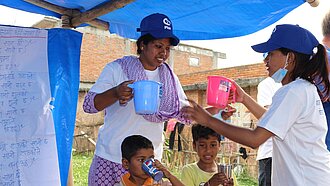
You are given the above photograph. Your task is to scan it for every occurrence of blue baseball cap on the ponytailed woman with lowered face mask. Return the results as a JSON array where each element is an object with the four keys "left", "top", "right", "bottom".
[{"left": 252, "top": 24, "right": 319, "bottom": 55}]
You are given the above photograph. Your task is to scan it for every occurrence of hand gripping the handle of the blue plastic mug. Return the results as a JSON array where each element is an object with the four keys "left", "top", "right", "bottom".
[{"left": 115, "top": 80, "right": 134, "bottom": 105}]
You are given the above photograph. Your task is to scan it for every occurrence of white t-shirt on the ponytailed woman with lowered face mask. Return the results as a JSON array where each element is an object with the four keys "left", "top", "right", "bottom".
[{"left": 259, "top": 79, "right": 330, "bottom": 186}]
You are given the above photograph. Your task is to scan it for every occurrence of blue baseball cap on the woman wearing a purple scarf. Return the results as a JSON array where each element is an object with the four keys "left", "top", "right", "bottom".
[{"left": 137, "top": 13, "right": 180, "bottom": 46}]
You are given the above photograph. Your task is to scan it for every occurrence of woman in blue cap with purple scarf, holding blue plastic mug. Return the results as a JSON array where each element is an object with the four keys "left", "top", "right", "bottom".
[{"left": 83, "top": 13, "right": 224, "bottom": 185}]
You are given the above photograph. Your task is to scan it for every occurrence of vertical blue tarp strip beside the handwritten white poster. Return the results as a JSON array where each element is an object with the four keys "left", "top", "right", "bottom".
[{"left": 48, "top": 28, "right": 82, "bottom": 186}]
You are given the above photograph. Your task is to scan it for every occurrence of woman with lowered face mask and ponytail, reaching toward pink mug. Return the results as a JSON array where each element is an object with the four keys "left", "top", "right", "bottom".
[{"left": 184, "top": 24, "right": 330, "bottom": 186}]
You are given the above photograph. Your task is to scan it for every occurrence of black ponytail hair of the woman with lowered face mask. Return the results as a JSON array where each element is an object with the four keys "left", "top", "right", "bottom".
[{"left": 279, "top": 44, "right": 330, "bottom": 101}]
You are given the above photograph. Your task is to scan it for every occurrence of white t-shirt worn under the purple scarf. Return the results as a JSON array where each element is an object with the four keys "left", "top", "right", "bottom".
[{"left": 90, "top": 62, "right": 187, "bottom": 163}]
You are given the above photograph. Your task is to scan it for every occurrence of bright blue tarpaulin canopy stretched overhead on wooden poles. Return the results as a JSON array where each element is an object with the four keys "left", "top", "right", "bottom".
[{"left": 0, "top": 0, "right": 305, "bottom": 40}]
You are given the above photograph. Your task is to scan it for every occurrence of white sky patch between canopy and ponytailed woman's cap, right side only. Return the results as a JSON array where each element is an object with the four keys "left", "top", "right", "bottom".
[{"left": 182, "top": 0, "right": 330, "bottom": 68}]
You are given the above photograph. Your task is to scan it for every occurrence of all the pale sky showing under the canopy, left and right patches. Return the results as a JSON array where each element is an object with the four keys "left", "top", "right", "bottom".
[{"left": 0, "top": 0, "right": 330, "bottom": 68}]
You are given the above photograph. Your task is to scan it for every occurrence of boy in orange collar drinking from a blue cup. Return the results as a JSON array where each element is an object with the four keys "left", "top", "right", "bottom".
[{"left": 117, "top": 135, "right": 183, "bottom": 186}]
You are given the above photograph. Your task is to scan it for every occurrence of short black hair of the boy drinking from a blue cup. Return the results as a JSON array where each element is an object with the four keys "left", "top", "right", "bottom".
[{"left": 121, "top": 135, "right": 154, "bottom": 161}]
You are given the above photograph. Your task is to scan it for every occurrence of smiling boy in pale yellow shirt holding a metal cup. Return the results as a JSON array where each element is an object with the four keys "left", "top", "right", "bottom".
[{"left": 181, "top": 124, "right": 237, "bottom": 186}]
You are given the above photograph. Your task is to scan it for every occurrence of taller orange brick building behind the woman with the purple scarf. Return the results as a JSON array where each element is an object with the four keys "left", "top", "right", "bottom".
[{"left": 80, "top": 30, "right": 222, "bottom": 82}]
